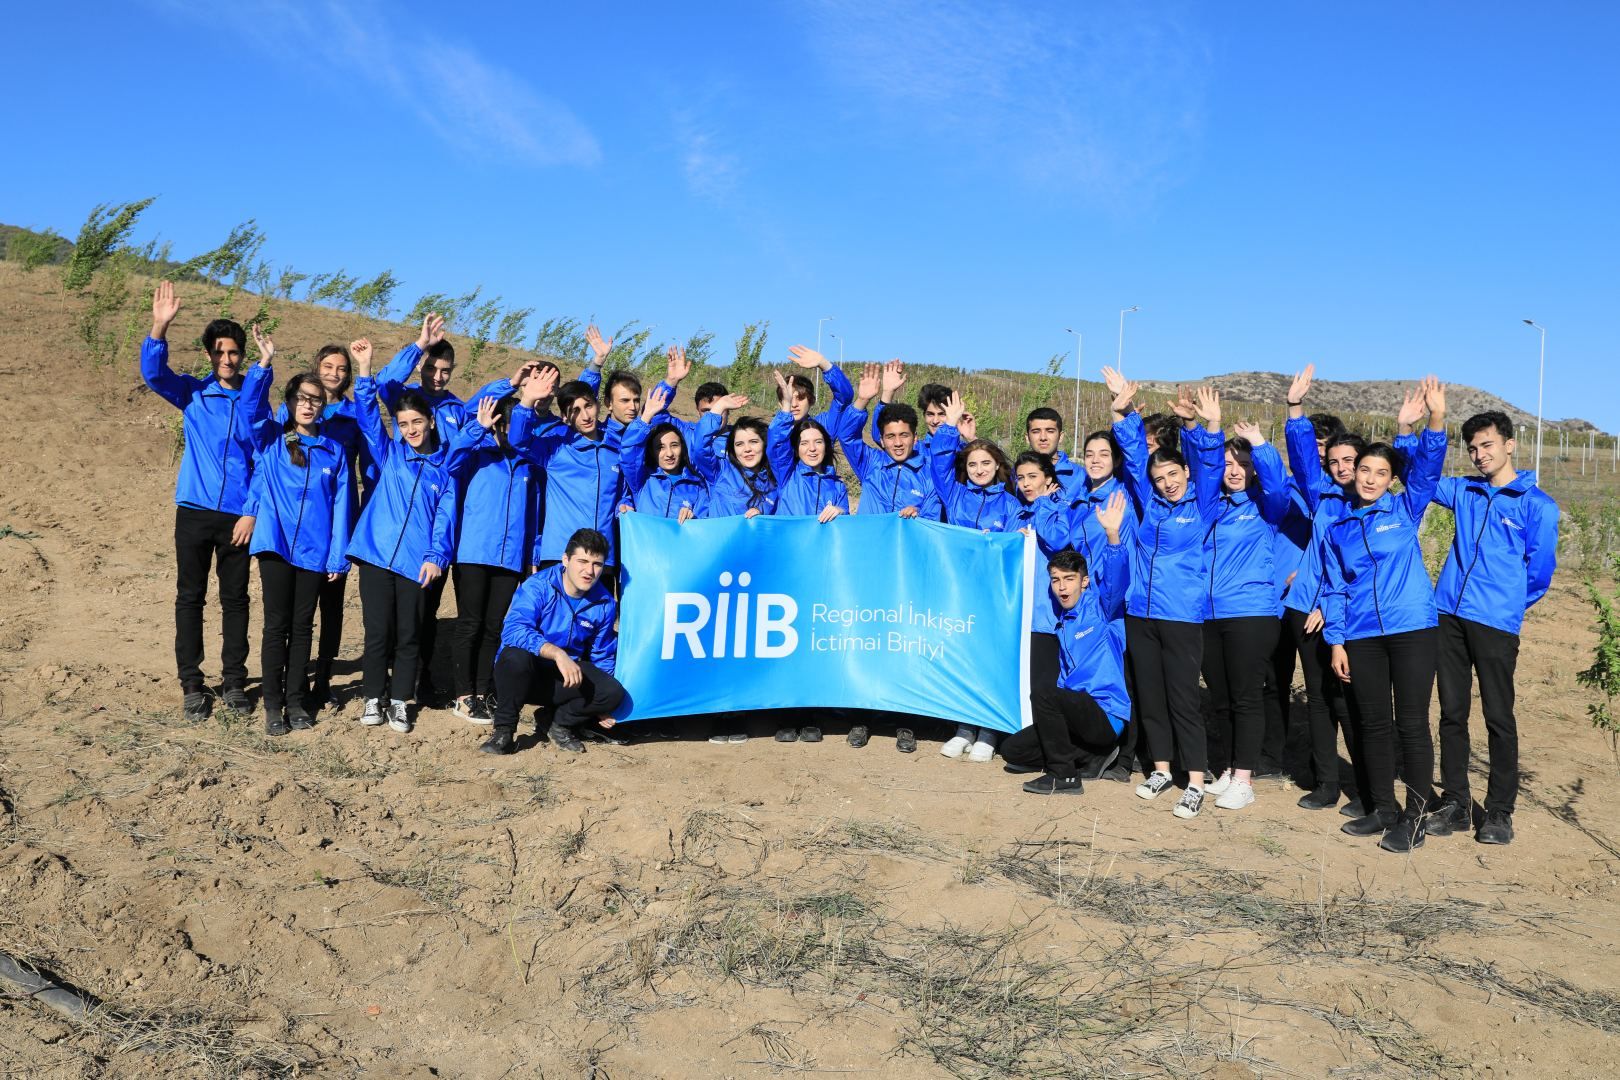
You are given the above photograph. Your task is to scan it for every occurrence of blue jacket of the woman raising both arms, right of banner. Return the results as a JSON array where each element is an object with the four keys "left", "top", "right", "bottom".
[{"left": 1113, "top": 413, "right": 1225, "bottom": 622}]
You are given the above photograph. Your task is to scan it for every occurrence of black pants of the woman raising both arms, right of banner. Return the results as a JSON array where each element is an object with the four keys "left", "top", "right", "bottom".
[{"left": 1124, "top": 615, "right": 1209, "bottom": 771}]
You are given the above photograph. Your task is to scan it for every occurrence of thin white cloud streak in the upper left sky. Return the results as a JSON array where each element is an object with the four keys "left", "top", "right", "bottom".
[{"left": 145, "top": 0, "right": 603, "bottom": 167}]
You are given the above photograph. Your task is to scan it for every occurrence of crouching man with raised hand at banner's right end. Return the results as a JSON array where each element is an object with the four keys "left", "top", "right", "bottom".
[{"left": 1001, "top": 492, "right": 1131, "bottom": 795}]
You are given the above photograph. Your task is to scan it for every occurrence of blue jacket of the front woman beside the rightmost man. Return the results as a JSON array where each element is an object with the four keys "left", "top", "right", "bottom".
[{"left": 1322, "top": 429, "right": 1447, "bottom": 644}]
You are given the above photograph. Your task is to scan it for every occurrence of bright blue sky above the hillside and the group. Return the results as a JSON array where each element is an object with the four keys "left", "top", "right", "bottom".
[{"left": 9, "top": 0, "right": 1620, "bottom": 431}]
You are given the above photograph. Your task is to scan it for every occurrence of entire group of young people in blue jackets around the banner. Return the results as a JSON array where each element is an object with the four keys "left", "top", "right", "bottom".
[{"left": 141, "top": 282, "right": 1558, "bottom": 852}]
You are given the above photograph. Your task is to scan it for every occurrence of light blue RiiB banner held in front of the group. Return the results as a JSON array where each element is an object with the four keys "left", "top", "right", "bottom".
[{"left": 617, "top": 513, "right": 1035, "bottom": 732}]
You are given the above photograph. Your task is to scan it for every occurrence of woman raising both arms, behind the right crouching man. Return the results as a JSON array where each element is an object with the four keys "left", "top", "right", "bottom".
[{"left": 1103, "top": 368, "right": 1223, "bottom": 818}]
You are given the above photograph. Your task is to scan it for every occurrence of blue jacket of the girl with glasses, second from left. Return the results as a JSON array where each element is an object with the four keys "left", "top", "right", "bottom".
[{"left": 241, "top": 419, "right": 353, "bottom": 573}]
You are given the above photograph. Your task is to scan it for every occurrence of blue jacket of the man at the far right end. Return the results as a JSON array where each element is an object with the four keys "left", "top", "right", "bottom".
[{"left": 1434, "top": 470, "right": 1558, "bottom": 635}]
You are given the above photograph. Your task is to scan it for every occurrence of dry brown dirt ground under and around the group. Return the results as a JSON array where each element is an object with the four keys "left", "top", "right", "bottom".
[{"left": 0, "top": 266, "right": 1620, "bottom": 1080}]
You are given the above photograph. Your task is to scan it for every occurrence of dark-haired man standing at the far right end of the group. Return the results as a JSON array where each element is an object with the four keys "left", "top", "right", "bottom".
[{"left": 1429, "top": 411, "right": 1558, "bottom": 844}]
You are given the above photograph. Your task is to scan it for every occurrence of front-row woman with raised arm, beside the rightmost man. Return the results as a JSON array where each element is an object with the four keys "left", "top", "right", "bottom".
[{"left": 1322, "top": 376, "right": 1447, "bottom": 852}]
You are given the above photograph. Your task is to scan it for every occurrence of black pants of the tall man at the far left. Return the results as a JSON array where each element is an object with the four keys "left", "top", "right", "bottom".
[{"left": 175, "top": 507, "right": 248, "bottom": 693}]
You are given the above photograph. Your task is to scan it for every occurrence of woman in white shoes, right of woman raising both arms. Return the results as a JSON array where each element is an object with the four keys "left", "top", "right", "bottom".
[{"left": 1204, "top": 423, "right": 1293, "bottom": 810}]
